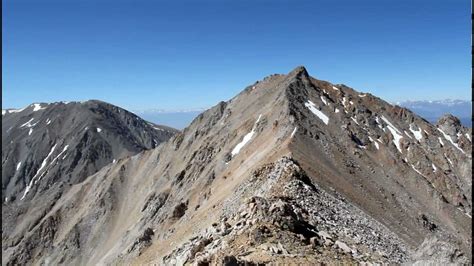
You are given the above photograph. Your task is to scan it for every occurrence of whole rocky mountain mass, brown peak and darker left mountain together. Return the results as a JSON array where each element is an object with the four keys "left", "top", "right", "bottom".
[{"left": 2, "top": 67, "right": 472, "bottom": 265}]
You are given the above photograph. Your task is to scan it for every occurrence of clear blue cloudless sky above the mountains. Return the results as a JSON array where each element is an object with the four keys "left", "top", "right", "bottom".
[{"left": 2, "top": 0, "right": 471, "bottom": 110}]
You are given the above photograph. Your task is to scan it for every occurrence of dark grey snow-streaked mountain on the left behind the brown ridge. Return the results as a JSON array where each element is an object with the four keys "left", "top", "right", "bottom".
[{"left": 2, "top": 101, "right": 177, "bottom": 264}]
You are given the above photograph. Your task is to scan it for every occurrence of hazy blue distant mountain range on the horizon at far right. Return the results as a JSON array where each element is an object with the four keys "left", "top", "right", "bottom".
[{"left": 396, "top": 99, "right": 472, "bottom": 127}]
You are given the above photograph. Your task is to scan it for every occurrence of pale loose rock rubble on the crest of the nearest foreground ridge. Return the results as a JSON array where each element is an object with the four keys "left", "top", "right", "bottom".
[{"left": 163, "top": 157, "right": 407, "bottom": 265}]
